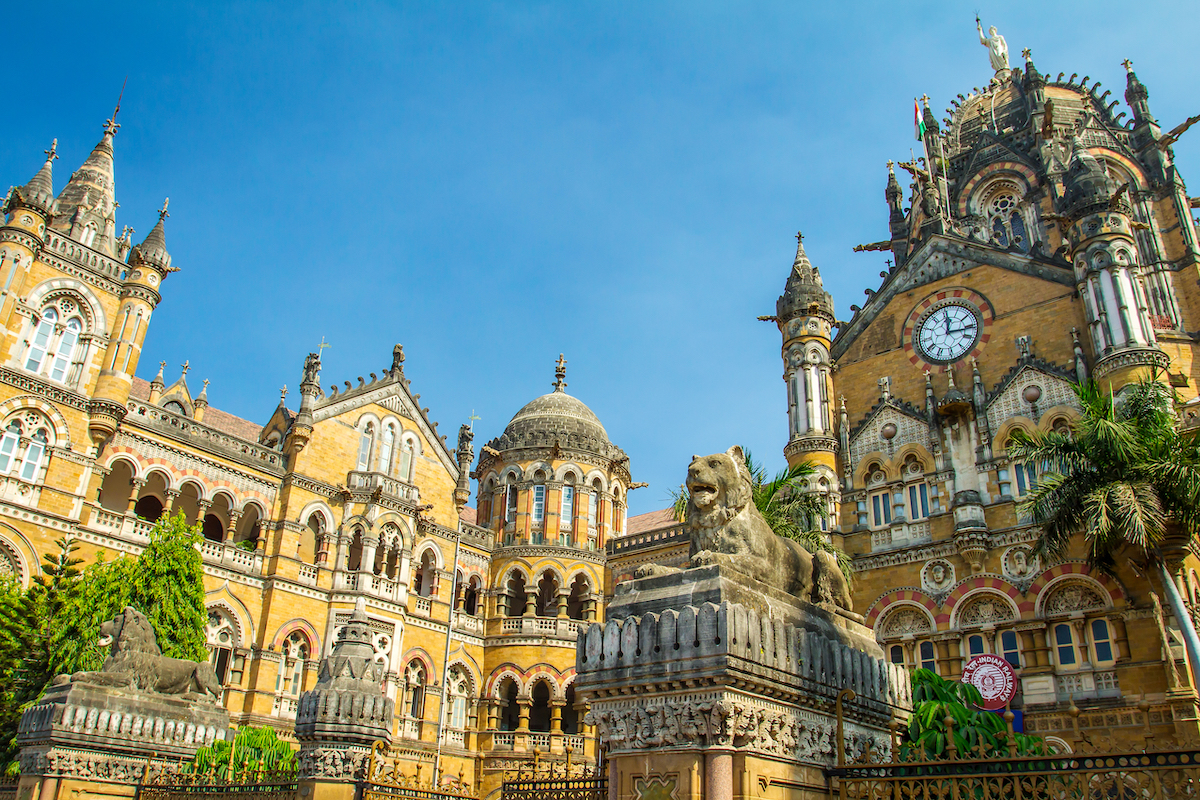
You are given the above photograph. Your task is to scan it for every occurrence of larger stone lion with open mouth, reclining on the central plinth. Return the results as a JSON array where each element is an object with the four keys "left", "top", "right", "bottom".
[{"left": 642, "top": 445, "right": 853, "bottom": 612}]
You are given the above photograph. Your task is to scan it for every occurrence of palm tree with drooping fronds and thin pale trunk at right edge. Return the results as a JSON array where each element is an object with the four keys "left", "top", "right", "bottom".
[{"left": 1008, "top": 379, "right": 1200, "bottom": 686}]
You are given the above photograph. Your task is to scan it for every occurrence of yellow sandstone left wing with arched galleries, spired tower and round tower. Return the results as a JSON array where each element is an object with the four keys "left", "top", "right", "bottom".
[{"left": 0, "top": 121, "right": 630, "bottom": 792}]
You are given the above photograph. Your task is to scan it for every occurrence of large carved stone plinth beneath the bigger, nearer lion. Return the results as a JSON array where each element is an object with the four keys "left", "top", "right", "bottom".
[{"left": 575, "top": 566, "right": 911, "bottom": 800}]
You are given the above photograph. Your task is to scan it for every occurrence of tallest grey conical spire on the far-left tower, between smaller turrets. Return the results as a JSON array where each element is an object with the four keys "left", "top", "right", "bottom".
[{"left": 52, "top": 113, "right": 121, "bottom": 257}]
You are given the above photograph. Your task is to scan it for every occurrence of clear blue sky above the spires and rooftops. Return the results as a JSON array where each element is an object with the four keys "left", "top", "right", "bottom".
[{"left": 0, "top": 1, "right": 1200, "bottom": 513}]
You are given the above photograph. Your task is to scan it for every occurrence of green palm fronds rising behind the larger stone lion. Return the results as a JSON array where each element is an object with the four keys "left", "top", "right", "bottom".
[{"left": 671, "top": 449, "right": 853, "bottom": 581}]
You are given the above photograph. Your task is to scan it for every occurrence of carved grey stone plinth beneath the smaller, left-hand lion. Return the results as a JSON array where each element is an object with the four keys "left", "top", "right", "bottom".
[{"left": 17, "top": 682, "right": 233, "bottom": 798}]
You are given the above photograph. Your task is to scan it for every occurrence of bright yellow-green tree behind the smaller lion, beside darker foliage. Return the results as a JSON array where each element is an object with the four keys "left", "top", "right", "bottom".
[{"left": 126, "top": 512, "right": 208, "bottom": 661}]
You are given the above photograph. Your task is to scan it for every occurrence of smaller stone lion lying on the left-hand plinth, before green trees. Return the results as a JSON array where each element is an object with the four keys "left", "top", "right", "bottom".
[{"left": 55, "top": 606, "right": 221, "bottom": 702}]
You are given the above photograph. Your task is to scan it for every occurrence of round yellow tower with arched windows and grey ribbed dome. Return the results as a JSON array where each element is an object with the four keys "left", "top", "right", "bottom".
[{"left": 475, "top": 356, "right": 630, "bottom": 775}]
